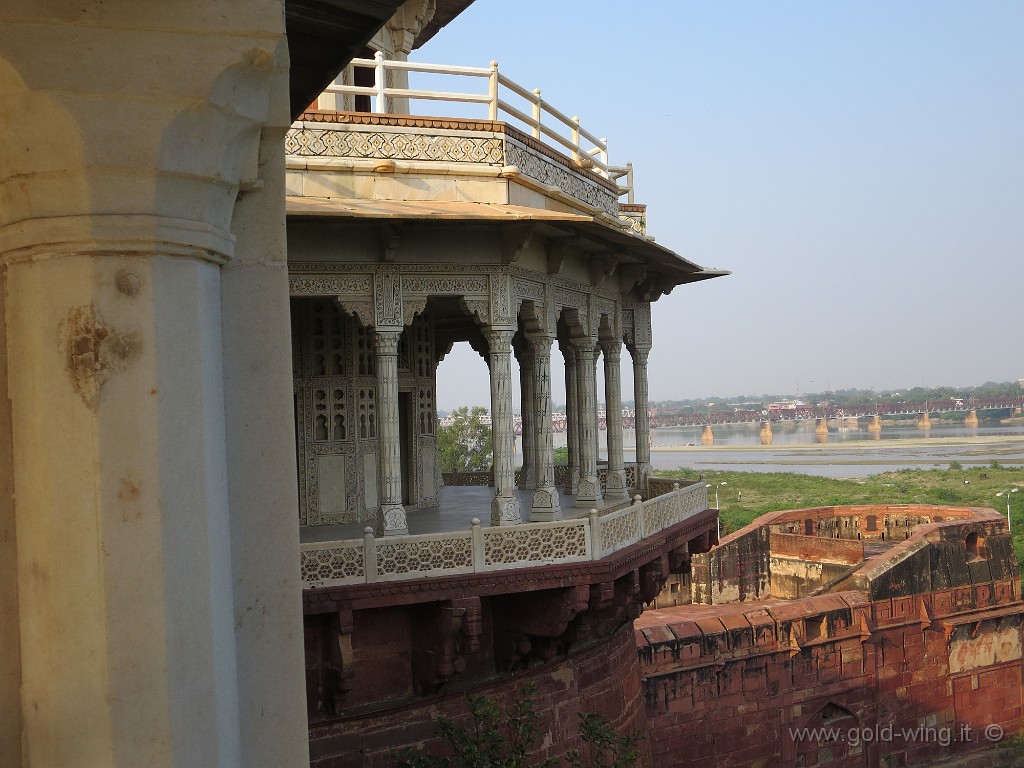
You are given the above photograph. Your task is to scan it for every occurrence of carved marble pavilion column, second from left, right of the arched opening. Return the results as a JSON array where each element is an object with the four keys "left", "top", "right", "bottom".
[{"left": 486, "top": 329, "right": 522, "bottom": 525}]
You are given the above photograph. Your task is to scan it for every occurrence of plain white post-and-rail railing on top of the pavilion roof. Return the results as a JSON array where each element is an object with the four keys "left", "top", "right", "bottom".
[{"left": 325, "top": 51, "right": 633, "bottom": 203}]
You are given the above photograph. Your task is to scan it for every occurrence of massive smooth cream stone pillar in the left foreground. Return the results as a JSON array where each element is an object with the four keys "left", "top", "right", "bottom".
[{"left": 0, "top": 7, "right": 308, "bottom": 768}]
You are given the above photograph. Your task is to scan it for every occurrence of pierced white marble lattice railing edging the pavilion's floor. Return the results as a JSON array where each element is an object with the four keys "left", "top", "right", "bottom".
[{"left": 300, "top": 482, "right": 708, "bottom": 588}]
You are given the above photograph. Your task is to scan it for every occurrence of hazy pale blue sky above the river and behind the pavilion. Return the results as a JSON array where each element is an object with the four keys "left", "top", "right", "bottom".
[{"left": 414, "top": 0, "right": 1024, "bottom": 409}]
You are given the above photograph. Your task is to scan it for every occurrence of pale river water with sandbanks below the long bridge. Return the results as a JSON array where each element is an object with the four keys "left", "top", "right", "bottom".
[{"left": 555, "top": 421, "right": 1024, "bottom": 477}]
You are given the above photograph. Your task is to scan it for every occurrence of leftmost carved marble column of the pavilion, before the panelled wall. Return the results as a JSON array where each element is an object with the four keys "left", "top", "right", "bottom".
[{"left": 374, "top": 328, "right": 409, "bottom": 536}]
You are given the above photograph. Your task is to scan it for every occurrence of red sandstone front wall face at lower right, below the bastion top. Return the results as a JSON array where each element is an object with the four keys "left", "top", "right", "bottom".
[{"left": 638, "top": 582, "right": 1024, "bottom": 768}]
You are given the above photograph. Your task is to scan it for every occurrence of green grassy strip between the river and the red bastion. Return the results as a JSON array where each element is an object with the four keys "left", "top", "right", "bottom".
[{"left": 654, "top": 465, "right": 1024, "bottom": 562}]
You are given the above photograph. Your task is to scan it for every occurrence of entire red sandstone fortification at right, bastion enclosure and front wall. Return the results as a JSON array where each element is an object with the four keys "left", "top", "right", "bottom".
[{"left": 636, "top": 506, "right": 1024, "bottom": 768}]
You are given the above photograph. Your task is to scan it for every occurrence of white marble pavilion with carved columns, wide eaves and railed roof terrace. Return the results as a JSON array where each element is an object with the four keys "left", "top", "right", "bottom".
[{"left": 286, "top": 3, "right": 723, "bottom": 536}]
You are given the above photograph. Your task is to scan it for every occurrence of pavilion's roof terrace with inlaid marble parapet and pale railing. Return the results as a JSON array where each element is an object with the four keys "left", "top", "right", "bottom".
[{"left": 286, "top": 52, "right": 647, "bottom": 241}]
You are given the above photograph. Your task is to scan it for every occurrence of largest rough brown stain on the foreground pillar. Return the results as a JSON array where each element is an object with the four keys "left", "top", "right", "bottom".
[{"left": 60, "top": 304, "right": 142, "bottom": 411}]
